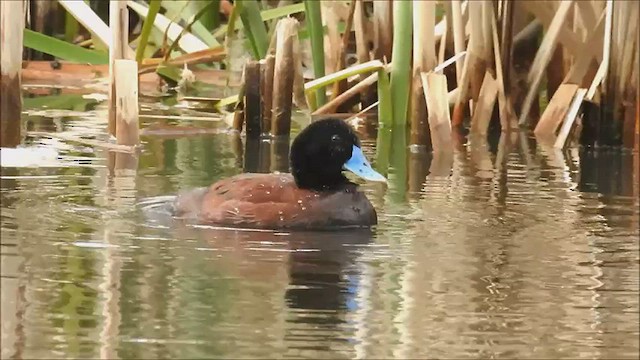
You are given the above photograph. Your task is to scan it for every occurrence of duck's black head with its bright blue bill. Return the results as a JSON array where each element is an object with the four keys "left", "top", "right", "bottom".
[{"left": 290, "top": 118, "right": 384, "bottom": 190}]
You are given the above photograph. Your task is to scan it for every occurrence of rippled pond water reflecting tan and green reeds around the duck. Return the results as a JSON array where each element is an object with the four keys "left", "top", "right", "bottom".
[{"left": 1, "top": 93, "right": 640, "bottom": 359}]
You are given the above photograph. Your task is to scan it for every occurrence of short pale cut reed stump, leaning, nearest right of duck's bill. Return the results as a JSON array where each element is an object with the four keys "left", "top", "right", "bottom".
[{"left": 420, "top": 73, "right": 453, "bottom": 152}]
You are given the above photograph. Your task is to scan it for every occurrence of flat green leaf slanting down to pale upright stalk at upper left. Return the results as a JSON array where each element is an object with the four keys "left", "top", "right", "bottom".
[{"left": 23, "top": 29, "right": 109, "bottom": 65}]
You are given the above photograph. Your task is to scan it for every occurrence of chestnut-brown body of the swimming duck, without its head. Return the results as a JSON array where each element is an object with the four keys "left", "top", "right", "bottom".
[{"left": 174, "top": 174, "right": 377, "bottom": 230}]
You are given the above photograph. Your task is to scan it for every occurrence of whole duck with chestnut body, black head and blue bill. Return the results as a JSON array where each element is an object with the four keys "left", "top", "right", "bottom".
[{"left": 172, "top": 117, "right": 386, "bottom": 230}]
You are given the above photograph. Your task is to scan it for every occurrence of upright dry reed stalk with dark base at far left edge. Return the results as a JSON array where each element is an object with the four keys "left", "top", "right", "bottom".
[{"left": 0, "top": 1, "right": 26, "bottom": 147}]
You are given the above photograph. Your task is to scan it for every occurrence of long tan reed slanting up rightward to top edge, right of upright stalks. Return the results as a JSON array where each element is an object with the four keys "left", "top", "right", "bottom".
[{"left": 519, "top": 0, "right": 573, "bottom": 125}]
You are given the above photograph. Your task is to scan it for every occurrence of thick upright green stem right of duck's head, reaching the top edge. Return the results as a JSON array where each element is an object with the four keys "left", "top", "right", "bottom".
[{"left": 390, "top": 1, "right": 413, "bottom": 125}]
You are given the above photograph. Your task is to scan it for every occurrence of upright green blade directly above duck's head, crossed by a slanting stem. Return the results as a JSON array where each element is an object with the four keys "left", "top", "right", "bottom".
[{"left": 304, "top": 0, "right": 327, "bottom": 106}]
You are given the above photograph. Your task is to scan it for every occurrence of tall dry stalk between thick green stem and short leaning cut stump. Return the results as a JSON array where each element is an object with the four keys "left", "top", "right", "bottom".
[{"left": 410, "top": 0, "right": 442, "bottom": 145}]
